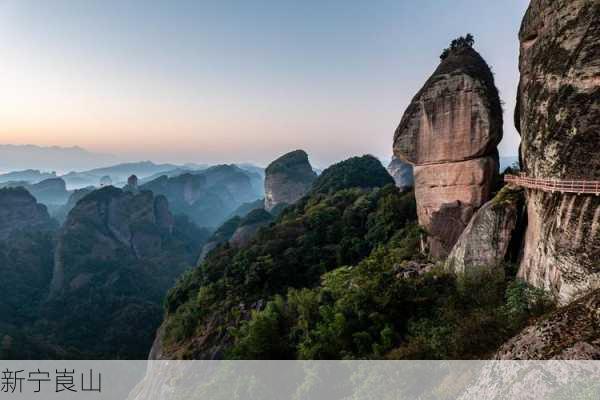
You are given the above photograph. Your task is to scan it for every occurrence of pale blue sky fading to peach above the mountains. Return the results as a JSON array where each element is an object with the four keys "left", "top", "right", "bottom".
[{"left": 0, "top": 0, "right": 528, "bottom": 167}]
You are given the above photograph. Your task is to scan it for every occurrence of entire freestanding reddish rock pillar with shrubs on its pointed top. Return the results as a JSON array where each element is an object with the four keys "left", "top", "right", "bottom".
[{"left": 394, "top": 41, "right": 502, "bottom": 257}]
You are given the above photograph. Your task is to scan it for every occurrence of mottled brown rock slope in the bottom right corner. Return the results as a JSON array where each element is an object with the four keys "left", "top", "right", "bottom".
[{"left": 496, "top": 290, "right": 600, "bottom": 360}]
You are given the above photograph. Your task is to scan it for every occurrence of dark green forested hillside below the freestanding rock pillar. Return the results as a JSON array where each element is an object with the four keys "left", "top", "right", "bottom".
[{"left": 161, "top": 156, "right": 547, "bottom": 359}]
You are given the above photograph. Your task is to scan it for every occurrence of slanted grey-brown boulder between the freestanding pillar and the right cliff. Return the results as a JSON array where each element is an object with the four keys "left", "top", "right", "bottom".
[{"left": 446, "top": 187, "right": 524, "bottom": 276}]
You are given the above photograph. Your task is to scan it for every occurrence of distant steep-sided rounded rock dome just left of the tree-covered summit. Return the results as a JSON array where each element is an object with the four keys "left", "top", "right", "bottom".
[{"left": 265, "top": 150, "right": 317, "bottom": 211}]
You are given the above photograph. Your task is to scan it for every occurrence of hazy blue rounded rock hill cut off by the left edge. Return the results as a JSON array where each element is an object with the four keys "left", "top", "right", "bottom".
[{"left": 0, "top": 187, "right": 53, "bottom": 240}]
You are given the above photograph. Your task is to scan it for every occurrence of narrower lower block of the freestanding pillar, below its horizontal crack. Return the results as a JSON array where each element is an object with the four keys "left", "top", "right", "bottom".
[{"left": 415, "top": 157, "right": 498, "bottom": 257}]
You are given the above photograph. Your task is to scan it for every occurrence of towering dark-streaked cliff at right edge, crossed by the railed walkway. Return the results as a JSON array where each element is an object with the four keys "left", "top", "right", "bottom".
[{"left": 515, "top": 0, "right": 600, "bottom": 303}]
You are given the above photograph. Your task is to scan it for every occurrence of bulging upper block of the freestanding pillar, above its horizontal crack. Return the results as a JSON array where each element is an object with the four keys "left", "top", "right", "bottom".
[{"left": 394, "top": 45, "right": 502, "bottom": 165}]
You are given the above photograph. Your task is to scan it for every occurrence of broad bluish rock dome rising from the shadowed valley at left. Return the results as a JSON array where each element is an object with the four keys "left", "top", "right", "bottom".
[{"left": 51, "top": 186, "right": 173, "bottom": 296}]
